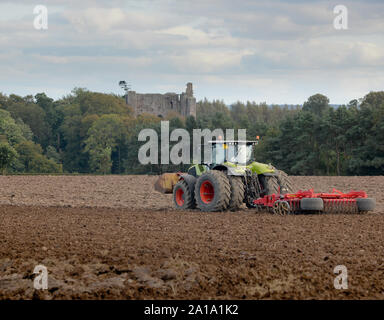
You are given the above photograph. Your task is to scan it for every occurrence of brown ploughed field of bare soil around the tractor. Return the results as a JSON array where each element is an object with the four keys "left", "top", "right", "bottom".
[{"left": 0, "top": 176, "right": 384, "bottom": 299}]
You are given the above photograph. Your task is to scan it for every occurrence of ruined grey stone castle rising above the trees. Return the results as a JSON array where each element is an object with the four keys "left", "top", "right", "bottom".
[{"left": 126, "top": 83, "right": 196, "bottom": 118}]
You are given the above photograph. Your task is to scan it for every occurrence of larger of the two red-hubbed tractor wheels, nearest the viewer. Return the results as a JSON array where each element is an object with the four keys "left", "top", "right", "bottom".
[{"left": 195, "top": 170, "right": 231, "bottom": 212}]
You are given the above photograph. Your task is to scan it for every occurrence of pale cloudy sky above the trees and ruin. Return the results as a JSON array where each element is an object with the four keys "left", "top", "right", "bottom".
[{"left": 0, "top": 0, "right": 384, "bottom": 104}]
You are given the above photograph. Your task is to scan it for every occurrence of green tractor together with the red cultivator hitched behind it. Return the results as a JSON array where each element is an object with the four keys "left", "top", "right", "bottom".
[{"left": 155, "top": 140, "right": 375, "bottom": 215}]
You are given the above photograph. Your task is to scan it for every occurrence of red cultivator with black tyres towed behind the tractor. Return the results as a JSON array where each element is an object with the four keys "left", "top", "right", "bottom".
[{"left": 253, "top": 189, "right": 376, "bottom": 215}]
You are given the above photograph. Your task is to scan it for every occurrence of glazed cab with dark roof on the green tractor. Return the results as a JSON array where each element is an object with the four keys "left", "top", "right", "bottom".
[{"left": 208, "top": 140, "right": 258, "bottom": 166}]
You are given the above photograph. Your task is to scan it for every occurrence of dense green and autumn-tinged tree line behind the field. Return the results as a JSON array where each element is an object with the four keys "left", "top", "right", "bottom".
[{"left": 0, "top": 88, "right": 384, "bottom": 175}]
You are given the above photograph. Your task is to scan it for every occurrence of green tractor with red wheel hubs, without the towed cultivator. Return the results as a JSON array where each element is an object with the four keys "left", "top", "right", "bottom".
[{"left": 155, "top": 140, "right": 294, "bottom": 212}]
